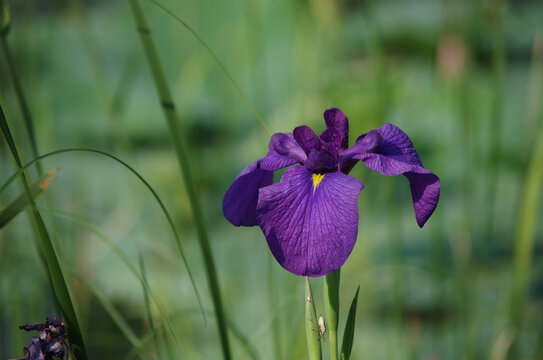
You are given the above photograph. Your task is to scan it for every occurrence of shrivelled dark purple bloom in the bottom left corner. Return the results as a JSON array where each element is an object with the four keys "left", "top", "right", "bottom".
[{"left": 13, "top": 316, "right": 68, "bottom": 360}]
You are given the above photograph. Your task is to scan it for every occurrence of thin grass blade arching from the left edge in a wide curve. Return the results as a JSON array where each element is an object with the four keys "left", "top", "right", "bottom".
[{"left": 0, "top": 148, "right": 205, "bottom": 317}]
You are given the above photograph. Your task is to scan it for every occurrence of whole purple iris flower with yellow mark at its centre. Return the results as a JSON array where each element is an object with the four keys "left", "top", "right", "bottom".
[{"left": 223, "top": 108, "right": 441, "bottom": 276}]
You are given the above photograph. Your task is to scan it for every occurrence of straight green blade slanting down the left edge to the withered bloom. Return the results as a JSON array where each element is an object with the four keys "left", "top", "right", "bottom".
[{"left": 0, "top": 105, "right": 87, "bottom": 360}]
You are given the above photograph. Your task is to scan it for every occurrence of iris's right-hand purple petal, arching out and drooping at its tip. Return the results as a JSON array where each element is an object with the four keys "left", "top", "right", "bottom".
[{"left": 340, "top": 124, "right": 441, "bottom": 227}]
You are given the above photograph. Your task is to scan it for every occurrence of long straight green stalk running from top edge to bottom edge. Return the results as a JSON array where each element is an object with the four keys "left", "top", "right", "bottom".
[{"left": 129, "top": 0, "right": 231, "bottom": 359}]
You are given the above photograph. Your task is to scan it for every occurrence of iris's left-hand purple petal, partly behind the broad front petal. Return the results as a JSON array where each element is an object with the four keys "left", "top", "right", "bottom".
[{"left": 222, "top": 154, "right": 299, "bottom": 226}]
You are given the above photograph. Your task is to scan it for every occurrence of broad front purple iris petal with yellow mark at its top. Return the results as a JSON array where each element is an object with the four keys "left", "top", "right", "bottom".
[{"left": 257, "top": 165, "right": 363, "bottom": 276}]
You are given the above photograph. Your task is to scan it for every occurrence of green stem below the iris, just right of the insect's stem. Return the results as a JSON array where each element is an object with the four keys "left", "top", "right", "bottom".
[{"left": 324, "top": 268, "right": 341, "bottom": 360}]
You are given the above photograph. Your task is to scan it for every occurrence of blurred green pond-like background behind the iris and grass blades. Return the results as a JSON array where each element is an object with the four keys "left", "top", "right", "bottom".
[{"left": 0, "top": 0, "right": 543, "bottom": 360}]
